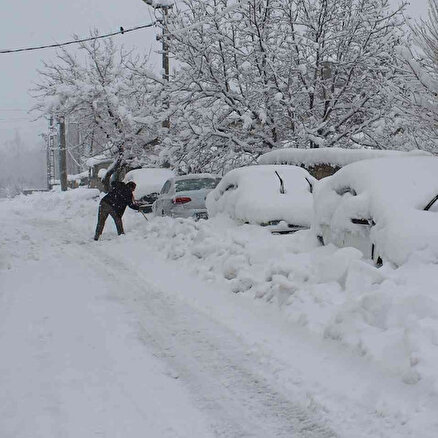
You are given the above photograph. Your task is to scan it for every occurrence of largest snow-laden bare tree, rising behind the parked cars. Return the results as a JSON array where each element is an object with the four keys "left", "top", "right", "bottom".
[{"left": 163, "top": 0, "right": 403, "bottom": 168}]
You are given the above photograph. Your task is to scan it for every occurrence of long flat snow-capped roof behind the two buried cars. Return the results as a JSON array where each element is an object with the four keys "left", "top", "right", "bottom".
[{"left": 258, "top": 148, "right": 430, "bottom": 167}]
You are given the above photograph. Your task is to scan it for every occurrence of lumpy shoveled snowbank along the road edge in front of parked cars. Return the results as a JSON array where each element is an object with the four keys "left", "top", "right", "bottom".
[{"left": 4, "top": 188, "right": 438, "bottom": 393}]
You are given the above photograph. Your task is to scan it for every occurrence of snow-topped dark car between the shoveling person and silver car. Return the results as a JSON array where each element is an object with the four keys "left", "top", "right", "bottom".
[{"left": 123, "top": 168, "right": 175, "bottom": 213}]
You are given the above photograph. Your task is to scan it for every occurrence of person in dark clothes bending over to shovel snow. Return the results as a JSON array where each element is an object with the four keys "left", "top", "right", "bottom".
[{"left": 94, "top": 181, "right": 139, "bottom": 240}]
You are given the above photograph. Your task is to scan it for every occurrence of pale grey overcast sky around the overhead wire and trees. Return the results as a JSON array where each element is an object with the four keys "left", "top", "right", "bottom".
[{"left": 0, "top": 0, "right": 427, "bottom": 152}]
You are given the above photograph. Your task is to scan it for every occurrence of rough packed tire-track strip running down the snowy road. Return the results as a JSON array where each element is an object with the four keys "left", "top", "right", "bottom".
[{"left": 72, "top": 241, "right": 337, "bottom": 438}]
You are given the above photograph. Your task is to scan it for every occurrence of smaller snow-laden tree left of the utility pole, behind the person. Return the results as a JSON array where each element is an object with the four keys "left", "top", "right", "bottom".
[{"left": 34, "top": 34, "right": 168, "bottom": 175}]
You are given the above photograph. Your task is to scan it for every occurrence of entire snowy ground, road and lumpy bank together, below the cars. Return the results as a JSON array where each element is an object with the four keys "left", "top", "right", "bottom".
[{"left": 0, "top": 188, "right": 438, "bottom": 438}]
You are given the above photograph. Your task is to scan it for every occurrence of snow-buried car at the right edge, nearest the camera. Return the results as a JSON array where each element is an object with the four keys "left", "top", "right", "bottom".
[{"left": 314, "top": 156, "right": 438, "bottom": 265}]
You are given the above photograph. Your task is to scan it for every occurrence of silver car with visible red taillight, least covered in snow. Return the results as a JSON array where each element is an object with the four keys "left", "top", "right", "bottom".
[{"left": 152, "top": 173, "right": 220, "bottom": 219}]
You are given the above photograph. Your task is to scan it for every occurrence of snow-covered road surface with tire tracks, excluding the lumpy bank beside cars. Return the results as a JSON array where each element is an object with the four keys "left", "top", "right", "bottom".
[{"left": 0, "top": 189, "right": 438, "bottom": 438}]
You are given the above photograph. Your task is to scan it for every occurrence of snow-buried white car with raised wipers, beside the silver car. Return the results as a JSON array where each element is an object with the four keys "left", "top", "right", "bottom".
[{"left": 207, "top": 165, "right": 316, "bottom": 233}]
